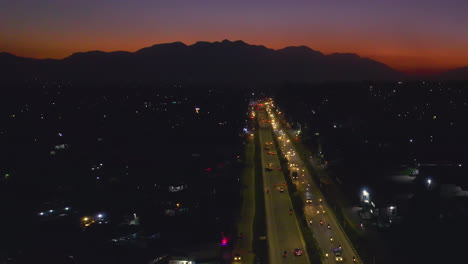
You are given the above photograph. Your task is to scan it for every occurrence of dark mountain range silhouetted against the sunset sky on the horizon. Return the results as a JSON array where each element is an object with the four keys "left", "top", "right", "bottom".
[{"left": 0, "top": 40, "right": 404, "bottom": 84}]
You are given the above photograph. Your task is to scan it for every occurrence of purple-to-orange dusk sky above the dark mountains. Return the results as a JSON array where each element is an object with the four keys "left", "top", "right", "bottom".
[{"left": 0, "top": 0, "right": 468, "bottom": 73}]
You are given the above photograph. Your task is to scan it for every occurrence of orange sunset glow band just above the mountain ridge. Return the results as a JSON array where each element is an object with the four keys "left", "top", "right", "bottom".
[{"left": 0, "top": 35, "right": 468, "bottom": 75}]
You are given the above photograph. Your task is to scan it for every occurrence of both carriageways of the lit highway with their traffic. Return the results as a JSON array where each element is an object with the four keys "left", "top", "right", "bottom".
[{"left": 232, "top": 101, "right": 362, "bottom": 264}]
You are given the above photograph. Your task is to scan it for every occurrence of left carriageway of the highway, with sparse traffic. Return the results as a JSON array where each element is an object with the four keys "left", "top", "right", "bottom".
[{"left": 257, "top": 111, "right": 310, "bottom": 264}]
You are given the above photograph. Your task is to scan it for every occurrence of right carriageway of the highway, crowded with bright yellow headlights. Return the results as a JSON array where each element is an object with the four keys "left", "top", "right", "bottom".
[{"left": 267, "top": 103, "right": 361, "bottom": 264}]
